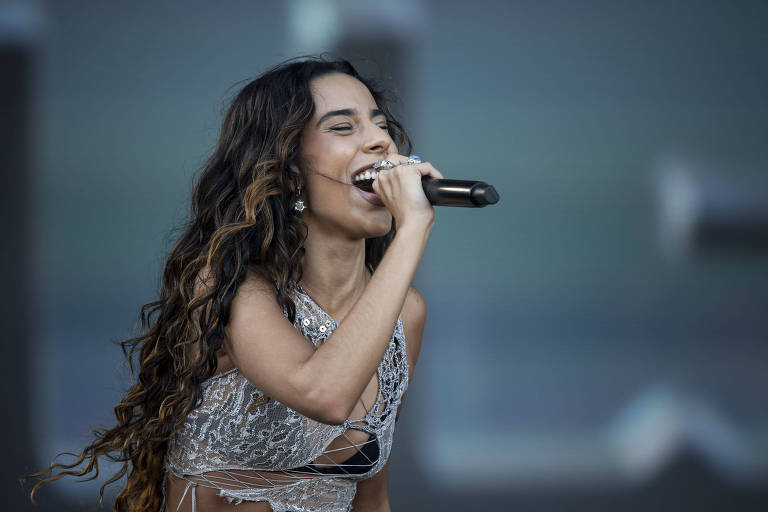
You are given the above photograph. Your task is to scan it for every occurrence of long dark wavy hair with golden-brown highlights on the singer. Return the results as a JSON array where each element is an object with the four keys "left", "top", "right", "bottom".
[{"left": 28, "top": 57, "right": 411, "bottom": 512}]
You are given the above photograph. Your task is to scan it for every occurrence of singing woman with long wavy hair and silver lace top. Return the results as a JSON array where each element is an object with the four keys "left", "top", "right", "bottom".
[{"left": 28, "top": 59, "right": 442, "bottom": 512}]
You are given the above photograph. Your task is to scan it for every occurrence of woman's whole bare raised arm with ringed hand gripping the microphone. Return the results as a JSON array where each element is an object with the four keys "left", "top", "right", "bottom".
[{"left": 226, "top": 160, "right": 442, "bottom": 424}]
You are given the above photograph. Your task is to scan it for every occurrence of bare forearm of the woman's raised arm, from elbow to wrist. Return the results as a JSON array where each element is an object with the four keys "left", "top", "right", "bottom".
[{"left": 302, "top": 219, "right": 432, "bottom": 421}]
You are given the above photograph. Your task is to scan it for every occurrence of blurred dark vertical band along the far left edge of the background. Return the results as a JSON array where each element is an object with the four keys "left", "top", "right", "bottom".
[{"left": 0, "top": 5, "right": 37, "bottom": 510}]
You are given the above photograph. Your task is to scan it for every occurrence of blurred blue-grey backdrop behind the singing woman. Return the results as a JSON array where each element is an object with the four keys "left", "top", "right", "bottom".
[{"left": 6, "top": 0, "right": 768, "bottom": 511}]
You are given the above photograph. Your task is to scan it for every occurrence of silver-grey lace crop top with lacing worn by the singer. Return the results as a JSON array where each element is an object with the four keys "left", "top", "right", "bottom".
[{"left": 165, "top": 286, "right": 408, "bottom": 512}]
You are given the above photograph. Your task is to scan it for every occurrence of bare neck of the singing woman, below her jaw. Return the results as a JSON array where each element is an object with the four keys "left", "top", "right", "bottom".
[{"left": 301, "top": 219, "right": 371, "bottom": 322}]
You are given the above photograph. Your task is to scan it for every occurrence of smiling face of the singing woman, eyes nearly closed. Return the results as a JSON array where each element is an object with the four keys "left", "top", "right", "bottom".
[{"left": 300, "top": 73, "right": 397, "bottom": 240}]
